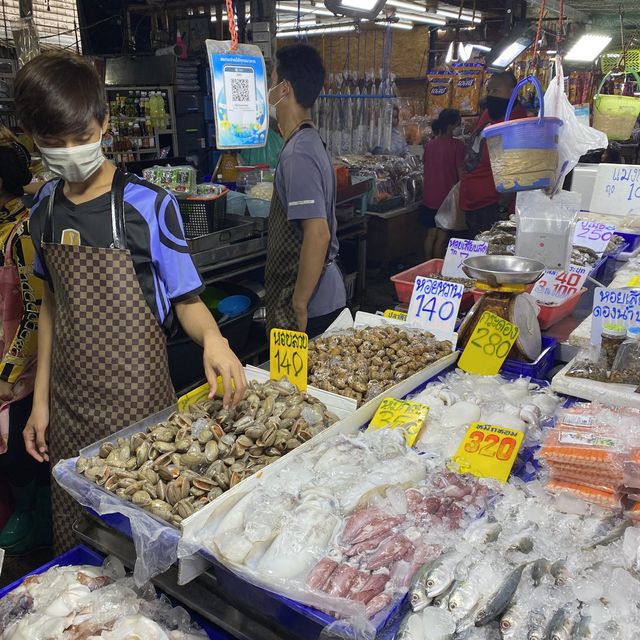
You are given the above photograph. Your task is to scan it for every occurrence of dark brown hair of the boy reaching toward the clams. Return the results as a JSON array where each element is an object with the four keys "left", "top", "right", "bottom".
[{"left": 14, "top": 51, "right": 107, "bottom": 137}]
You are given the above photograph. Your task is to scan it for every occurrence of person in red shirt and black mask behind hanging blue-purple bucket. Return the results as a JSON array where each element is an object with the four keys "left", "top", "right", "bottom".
[{"left": 460, "top": 71, "right": 527, "bottom": 238}]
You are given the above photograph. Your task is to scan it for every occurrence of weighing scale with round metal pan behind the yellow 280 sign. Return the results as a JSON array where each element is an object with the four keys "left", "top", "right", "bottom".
[{"left": 458, "top": 255, "right": 545, "bottom": 362}]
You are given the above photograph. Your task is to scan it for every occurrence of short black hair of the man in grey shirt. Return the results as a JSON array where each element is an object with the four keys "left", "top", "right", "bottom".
[{"left": 276, "top": 44, "right": 324, "bottom": 109}]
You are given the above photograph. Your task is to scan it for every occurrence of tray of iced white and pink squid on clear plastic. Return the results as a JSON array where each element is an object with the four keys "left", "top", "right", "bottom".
[{"left": 179, "top": 430, "right": 487, "bottom": 640}]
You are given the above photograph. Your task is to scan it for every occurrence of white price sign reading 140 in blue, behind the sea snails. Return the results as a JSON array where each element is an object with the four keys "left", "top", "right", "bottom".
[{"left": 407, "top": 276, "right": 464, "bottom": 333}]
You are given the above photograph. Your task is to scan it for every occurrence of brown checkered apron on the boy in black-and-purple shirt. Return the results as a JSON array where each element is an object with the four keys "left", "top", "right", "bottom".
[{"left": 42, "top": 170, "right": 175, "bottom": 553}]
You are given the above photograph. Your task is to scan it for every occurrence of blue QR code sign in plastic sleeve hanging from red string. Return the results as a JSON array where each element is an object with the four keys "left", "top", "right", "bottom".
[{"left": 206, "top": 40, "right": 269, "bottom": 149}]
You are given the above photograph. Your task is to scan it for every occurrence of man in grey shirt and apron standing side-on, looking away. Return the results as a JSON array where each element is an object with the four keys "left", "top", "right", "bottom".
[{"left": 265, "top": 45, "right": 346, "bottom": 336}]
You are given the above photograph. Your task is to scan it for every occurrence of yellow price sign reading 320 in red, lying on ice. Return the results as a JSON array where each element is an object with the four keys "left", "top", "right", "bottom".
[{"left": 452, "top": 422, "right": 524, "bottom": 482}]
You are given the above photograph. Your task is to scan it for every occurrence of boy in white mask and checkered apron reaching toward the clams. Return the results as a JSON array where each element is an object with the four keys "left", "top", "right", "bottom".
[{"left": 15, "top": 52, "right": 246, "bottom": 551}]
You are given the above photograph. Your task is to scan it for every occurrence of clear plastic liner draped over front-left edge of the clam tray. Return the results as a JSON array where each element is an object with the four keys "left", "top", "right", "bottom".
[{"left": 53, "top": 458, "right": 180, "bottom": 585}]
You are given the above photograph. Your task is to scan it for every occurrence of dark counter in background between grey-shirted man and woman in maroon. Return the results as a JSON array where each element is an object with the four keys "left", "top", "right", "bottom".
[{"left": 366, "top": 203, "right": 425, "bottom": 270}]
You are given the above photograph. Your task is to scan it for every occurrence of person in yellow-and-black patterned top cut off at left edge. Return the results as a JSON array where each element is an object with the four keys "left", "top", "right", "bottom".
[{"left": 0, "top": 127, "right": 51, "bottom": 555}]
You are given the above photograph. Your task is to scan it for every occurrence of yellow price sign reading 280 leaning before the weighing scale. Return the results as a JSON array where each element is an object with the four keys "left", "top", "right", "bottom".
[{"left": 458, "top": 311, "right": 519, "bottom": 376}]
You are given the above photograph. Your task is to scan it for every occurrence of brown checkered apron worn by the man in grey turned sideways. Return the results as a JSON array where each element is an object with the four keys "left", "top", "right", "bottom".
[{"left": 264, "top": 122, "right": 324, "bottom": 334}]
